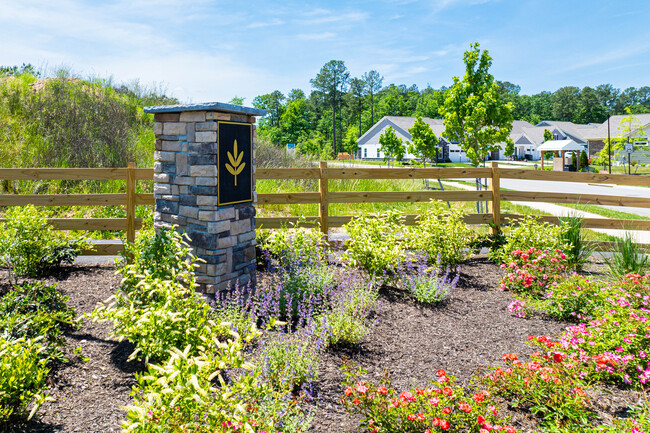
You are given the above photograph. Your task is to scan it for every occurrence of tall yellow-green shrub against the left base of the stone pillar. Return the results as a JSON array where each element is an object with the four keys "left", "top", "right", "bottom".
[{"left": 92, "top": 229, "right": 216, "bottom": 361}]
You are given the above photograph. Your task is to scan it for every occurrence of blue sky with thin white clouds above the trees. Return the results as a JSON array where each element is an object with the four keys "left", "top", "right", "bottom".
[{"left": 0, "top": 0, "right": 650, "bottom": 105}]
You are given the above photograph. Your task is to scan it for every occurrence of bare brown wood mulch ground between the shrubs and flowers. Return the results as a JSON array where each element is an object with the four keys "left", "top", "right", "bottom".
[{"left": 0, "top": 256, "right": 639, "bottom": 433}]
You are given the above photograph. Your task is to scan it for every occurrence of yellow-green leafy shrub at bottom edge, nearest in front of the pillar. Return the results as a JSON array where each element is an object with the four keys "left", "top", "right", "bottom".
[{"left": 122, "top": 335, "right": 309, "bottom": 433}]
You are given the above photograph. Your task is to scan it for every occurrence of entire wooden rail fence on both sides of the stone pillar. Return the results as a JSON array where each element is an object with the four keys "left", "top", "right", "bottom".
[{"left": 0, "top": 162, "right": 650, "bottom": 251}]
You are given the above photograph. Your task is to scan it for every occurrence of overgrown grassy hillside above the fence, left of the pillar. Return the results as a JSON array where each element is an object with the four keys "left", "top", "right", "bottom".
[{"left": 0, "top": 65, "right": 178, "bottom": 167}]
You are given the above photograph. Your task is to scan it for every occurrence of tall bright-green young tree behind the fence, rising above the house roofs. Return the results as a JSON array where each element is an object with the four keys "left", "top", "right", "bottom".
[{"left": 441, "top": 42, "right": 514, "bottom": 166}]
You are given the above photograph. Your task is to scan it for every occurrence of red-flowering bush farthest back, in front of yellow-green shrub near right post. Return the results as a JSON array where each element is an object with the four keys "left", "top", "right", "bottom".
[{"left": 500, "top": 247, "right": 567, "bottom": 295}]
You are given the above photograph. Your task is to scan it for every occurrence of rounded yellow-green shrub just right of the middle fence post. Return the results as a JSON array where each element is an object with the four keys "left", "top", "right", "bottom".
[{"left": 343, "top": 211, "right": 405, "bottom": 274}]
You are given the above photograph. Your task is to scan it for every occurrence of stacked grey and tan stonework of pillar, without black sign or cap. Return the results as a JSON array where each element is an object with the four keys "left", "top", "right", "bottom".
[{"left": 154, "top": 110, "right": 257, "bottom": 294}]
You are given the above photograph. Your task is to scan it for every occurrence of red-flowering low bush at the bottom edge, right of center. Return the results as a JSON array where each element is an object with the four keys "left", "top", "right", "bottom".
[{"left": 341, "top": 365, "right": 516, "bottom": 433}]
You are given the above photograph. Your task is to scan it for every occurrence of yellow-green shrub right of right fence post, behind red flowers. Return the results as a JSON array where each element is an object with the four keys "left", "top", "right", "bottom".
[{"left": 490, "top": 215, "right": 567, "bottom": 264}]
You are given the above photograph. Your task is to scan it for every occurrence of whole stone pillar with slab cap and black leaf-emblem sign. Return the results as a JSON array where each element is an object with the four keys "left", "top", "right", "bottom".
[{"left": 144, "top": 102, "right": 266, "bottom": 294}]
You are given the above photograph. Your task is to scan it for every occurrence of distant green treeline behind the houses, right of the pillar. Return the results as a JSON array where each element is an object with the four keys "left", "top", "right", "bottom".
[{"left": 253, "top": 60, "right": 650, "bottom": 156}]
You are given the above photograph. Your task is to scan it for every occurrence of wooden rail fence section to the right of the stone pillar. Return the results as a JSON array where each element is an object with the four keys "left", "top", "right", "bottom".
[{"left": 256, "top": 162, "right": 650, "bottom": 247}]
